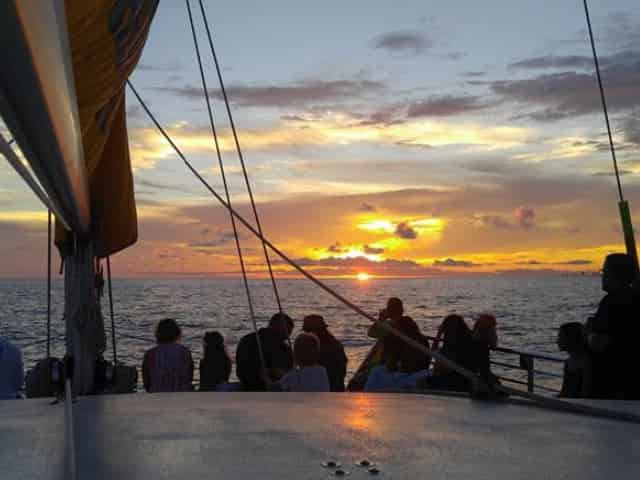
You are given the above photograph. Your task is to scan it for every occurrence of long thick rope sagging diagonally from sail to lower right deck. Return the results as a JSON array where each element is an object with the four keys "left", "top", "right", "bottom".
[{"left": 127, "top": 80, "right": 640, "bottom": 424}]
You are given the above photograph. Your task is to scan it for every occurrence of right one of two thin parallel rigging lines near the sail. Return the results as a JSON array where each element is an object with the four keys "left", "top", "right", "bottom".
[{"left": 198, "top": 0, "right": 282, "bottom": 314}]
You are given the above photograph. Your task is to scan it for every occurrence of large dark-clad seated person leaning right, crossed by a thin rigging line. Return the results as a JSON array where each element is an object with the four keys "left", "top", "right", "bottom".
[{"left": 236, "top": 313, "right": 293, "bottom": 392}]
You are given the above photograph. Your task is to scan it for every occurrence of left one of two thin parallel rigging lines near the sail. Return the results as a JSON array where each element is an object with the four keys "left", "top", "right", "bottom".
[{"left": 185, "top": 0, "right": 264, "bottom": 368}]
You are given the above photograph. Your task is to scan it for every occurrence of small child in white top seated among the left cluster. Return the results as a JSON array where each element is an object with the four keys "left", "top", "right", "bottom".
[{"left": 278, "top": 333, "right": 330, "bottom": 392}]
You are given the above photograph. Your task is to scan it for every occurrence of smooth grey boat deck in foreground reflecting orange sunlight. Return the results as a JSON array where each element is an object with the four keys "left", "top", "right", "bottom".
[{"left": 0, "top": 393, "right": 640, "bottom": 480}]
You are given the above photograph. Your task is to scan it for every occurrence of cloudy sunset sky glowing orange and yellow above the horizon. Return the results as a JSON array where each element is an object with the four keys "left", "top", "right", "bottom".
[{"left": 0, "top": 0, "right": 640, "bottom": 276}]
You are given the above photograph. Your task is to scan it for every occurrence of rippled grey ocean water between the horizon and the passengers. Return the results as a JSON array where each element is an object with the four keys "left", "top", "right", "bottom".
[{"left": 0, "top": 275, "right": 601, "bottom": 392}]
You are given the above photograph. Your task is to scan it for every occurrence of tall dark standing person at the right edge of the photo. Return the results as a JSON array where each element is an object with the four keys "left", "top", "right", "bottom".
[{"left": 586, "top": 253, "right": 640, "bottom": 399}]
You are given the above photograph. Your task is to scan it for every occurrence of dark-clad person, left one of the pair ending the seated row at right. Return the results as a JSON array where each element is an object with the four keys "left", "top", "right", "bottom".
[{"left": 427, "top": 315, "right": 473, "bottom": 391}]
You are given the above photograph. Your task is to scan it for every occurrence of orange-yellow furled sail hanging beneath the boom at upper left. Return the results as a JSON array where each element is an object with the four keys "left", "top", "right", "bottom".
[{"left": 56, "top": 0, "right": 158, "bottom": 257}]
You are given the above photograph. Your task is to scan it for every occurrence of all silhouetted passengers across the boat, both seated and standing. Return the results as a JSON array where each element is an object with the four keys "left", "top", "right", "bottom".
[{"left": 0, "top": 254, "right": 640, "bottom": 399}]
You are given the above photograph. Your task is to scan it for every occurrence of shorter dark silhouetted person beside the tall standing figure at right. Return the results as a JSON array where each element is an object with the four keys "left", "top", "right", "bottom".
[{"left": 557, "top": 322, "right": 591, "bottom": 398}]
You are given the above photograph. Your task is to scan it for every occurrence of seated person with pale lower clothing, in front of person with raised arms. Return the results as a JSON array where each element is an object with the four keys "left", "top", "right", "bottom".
[{"left": 364, "top": 317, "right": 430, "bottom": 392}]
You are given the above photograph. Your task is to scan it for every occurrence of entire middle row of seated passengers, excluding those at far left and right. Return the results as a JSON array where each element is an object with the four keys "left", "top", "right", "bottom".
[{"left": 142, "top": 298, "right": 497, "bottom": 392}]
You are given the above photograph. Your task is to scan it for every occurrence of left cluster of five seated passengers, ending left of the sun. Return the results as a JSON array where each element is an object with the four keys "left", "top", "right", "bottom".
[{"left": 142, "top": 313, "right": 347, "bottom": 392}]
